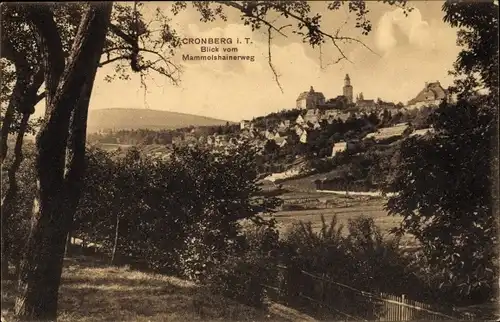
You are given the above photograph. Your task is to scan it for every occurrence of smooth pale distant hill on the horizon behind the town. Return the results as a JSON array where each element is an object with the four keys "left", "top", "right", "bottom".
[{"left": 87, "top": 108, "right": 233, "bottom": 133}]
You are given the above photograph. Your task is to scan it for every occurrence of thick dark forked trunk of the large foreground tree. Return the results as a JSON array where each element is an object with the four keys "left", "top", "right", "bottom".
[{"left": 16, "top": 2, "right": 112, "bottom": 320}]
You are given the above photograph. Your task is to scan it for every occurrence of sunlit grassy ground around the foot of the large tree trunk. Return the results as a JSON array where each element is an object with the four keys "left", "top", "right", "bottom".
[{"left": 2, "top": 257, "right": 315, "bottom": 322}]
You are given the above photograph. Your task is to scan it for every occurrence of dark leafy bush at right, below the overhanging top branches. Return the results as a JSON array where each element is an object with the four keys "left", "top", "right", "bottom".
[{"left": 387, "top": 99, "right": 497, "bottom": 302}]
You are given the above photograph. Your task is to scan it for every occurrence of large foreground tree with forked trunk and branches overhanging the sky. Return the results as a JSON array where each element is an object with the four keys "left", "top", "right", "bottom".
[{"left": 2, "top": 1, "right": 412, "bottom": 319}]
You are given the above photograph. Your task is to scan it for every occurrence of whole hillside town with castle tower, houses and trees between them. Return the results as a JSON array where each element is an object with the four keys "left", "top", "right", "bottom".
[{"left": 89, "top": 74, "right": 452, "bottom": 173}]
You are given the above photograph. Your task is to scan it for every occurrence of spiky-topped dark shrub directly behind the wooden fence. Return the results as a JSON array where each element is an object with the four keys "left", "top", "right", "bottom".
[{"left": 282, "top": 216, "right": 422, "bottom": 304}]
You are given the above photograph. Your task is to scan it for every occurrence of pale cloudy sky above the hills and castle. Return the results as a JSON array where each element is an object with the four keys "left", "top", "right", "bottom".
[{"left": 57, "top": 1, "right": 460, "bottom": 121}]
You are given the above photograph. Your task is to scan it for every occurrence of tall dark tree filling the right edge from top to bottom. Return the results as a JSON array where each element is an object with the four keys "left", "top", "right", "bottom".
[{"left": 387, "top": 1, "right": 498, "bottom": 302}]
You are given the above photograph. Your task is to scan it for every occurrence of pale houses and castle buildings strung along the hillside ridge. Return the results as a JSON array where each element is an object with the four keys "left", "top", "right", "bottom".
[{"left": 145, "top": 75, "right": 451, "bottom": 161}]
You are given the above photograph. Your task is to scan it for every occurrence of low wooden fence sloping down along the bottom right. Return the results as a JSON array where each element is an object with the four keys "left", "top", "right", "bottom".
[{"left": 263, "top": 266, "right": 474, "bottom": 321}]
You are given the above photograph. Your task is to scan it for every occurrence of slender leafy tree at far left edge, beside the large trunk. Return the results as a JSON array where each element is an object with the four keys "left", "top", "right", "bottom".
[{"left": 0, "top": 6, "right": 44, "bottom": 277}]
